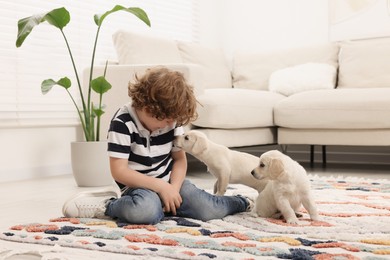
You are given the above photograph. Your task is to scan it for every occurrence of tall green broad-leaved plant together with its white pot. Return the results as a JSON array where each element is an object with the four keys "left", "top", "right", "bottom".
[{"left": 16, "top": 5, "right": 150, "bottom": 186}]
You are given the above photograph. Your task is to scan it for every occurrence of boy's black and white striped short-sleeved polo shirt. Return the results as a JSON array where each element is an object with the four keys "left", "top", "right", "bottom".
[{"left": 108, "top": 102, "right": 184, "bottom": 186}]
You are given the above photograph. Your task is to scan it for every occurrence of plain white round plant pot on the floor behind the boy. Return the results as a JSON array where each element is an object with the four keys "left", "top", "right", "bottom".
[{"left": 71, "top": 141, "right": 113, "bottom": 187}]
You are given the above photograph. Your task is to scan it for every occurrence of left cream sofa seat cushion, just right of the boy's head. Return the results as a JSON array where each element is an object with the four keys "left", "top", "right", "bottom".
[{"left": 192, "top": 88, "right": 286, "bottom": 129}]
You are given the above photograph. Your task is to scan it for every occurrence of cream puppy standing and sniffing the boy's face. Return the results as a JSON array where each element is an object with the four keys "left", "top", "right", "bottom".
[{"left": 173, "top": 130, "right": 268, "bottom": 195}]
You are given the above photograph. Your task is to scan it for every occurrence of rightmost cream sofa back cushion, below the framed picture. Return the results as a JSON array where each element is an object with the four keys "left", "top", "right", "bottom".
[{"left": 338, "top": 40, "right": 390, "bottom": 88}]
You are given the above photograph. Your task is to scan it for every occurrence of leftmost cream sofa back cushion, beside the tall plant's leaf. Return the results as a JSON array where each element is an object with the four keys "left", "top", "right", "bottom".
[{"left": 113, "top": 30, "right": 183, "bottom": 64}]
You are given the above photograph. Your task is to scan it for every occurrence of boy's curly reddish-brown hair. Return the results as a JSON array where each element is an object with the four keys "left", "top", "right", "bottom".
[{"left": 128, "top": 67, "right": 198, "bottom": 125}]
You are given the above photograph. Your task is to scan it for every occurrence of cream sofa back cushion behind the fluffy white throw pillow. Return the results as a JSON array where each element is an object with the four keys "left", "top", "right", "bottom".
[{"left": 233, "top": 44, "right": 339, "bottom": 90}]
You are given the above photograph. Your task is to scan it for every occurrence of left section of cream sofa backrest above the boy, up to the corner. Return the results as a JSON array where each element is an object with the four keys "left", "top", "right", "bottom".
[{"left": 113, "top": 30, "right": 232, "bottom": 89}]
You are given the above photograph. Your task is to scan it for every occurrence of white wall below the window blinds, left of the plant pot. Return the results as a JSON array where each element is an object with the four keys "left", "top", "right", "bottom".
[{"left": 0, "top": 126, "right": 80, "bottom": 182}]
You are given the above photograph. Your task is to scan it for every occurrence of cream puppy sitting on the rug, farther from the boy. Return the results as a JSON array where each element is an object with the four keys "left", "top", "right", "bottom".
[{"left": 252, "top": 150, "right": 318, "bottom": 224}]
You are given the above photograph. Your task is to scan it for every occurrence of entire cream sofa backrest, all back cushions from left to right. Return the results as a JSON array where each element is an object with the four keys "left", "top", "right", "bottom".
[{"left": 113, "top": 30, "right": 390, "bottom": 90}]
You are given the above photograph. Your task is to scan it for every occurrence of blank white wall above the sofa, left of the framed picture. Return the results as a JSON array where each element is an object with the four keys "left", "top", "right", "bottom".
[{"left": 200, "top": 0, "right": 328, "bottom": 57}]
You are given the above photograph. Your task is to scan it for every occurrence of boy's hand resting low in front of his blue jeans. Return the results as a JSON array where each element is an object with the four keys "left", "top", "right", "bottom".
[{"left": 157, "top": 182, "right": 183, "bottom": 215}]
